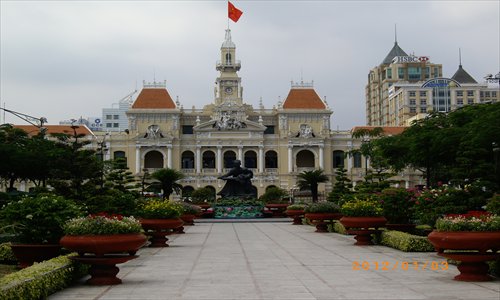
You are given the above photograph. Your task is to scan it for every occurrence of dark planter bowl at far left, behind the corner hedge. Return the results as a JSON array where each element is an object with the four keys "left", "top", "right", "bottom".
[{"left": 10, "top": 244, "right": 61, "bottom": 269}]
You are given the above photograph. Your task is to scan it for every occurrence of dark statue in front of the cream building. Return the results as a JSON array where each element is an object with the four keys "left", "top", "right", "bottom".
[{"left": 217, "top": 160, "right": 257, "bottom": 199}]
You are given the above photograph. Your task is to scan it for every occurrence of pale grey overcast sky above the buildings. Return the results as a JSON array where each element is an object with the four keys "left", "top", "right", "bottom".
[{"left": 0, "top": 0, "right": 500, "bottom": 129}]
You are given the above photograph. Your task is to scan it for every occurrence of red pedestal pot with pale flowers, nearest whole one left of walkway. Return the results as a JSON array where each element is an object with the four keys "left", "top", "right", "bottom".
[{"left": 60, "top": 213, "right": 147, "bottom": 285}]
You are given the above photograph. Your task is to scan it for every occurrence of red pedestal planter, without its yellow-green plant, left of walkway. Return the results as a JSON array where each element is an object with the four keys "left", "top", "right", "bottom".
[{"left": 139, "top": 218, "right": 184, "bottom": 247}]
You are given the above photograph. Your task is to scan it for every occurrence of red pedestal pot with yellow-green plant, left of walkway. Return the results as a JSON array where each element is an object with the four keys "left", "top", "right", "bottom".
[{"left": 138, "top": 199, "right": 184, "bottom": 247}]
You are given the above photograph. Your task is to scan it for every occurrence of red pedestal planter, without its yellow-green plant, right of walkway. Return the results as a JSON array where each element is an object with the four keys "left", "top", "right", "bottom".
[{"left": 340, "top": 217, "right": 387, "bottom": 246}]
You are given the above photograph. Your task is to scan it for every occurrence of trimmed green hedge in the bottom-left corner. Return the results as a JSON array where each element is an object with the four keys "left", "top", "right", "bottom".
[{"left": 0, "top": 253, "right": 87, "bottom": 300}]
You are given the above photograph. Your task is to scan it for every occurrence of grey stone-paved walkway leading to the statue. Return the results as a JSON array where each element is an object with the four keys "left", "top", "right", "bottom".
[{"left": 49, "top": 223, "right": 500, "bottom": 300}]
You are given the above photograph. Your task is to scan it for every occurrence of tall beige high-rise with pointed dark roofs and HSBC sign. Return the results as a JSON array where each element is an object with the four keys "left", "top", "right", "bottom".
[{"left": 366, "top": 42, "right": 500, "bottom": 126}]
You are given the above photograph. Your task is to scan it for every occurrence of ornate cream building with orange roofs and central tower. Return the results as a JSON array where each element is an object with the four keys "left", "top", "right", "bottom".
[{"left": 96, "top": 29, "right": 421, "bottom": 195}]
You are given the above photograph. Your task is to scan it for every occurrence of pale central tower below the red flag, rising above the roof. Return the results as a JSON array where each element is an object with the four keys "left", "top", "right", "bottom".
[{"left": 215, "top": 29, "right": 243, "bottom": 107}]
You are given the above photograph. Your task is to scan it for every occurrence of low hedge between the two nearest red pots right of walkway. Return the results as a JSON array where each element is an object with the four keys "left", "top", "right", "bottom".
[{"left": 380, "top": 230, "right": 435, "bottom": 252}]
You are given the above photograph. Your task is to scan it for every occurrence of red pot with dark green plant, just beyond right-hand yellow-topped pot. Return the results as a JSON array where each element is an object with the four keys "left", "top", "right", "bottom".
[{"left": 304, "top": 202, "right": 342, "bottom": 232}]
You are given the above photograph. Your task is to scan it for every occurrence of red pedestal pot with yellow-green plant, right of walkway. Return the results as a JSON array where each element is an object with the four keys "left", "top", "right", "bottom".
[{"left": 340, "top": 199, "right": 387, "bottom": 246}]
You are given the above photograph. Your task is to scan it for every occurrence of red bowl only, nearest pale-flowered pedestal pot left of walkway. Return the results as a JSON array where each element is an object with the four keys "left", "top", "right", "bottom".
[{"left": 60, "top": 233, "right": 147, "bottom": 256}]
